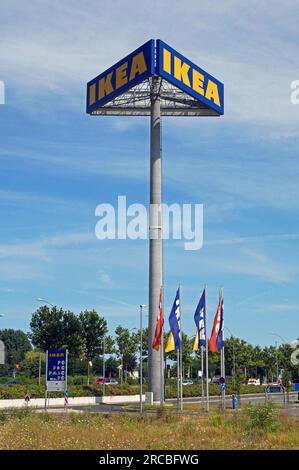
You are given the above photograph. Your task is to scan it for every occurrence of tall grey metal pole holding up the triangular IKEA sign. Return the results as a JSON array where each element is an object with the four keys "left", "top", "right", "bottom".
[{"left": 148, "top": 76, "right": 163, "bottom": 401}]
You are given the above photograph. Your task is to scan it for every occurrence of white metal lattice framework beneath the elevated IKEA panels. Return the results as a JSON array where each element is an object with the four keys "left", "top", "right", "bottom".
[{"left": 91, "top": 77, "right": 219, "bottom": 116}]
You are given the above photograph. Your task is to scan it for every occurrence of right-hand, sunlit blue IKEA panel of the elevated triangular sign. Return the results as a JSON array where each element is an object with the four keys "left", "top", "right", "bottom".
[{"left": 156, "top": 39, "right": 224, "bottom": 114}]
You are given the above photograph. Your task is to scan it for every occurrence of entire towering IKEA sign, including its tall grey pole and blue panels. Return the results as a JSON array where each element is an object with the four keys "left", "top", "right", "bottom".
[{"left": 86, "top": 39, "right": 224, "bottom": 402}]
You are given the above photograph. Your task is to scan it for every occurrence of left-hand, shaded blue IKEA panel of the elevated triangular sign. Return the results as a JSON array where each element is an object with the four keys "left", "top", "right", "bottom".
[{"left": 86, "top": 39, "right": 155, "bottom": 113}]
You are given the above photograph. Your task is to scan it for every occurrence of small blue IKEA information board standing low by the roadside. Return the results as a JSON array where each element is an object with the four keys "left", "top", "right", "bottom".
[{"left": 45, "top": 349, "right": 68, "bottom": 409}]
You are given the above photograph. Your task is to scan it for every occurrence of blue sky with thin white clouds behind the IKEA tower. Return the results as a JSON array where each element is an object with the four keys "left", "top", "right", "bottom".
[{"left": 0, "top": 0, "right": 299, "bottom": 344}]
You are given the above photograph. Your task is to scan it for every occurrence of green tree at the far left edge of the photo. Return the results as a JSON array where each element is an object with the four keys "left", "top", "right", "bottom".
[{"left": 0, "top": 329, "right": 32, "bottom": 368}]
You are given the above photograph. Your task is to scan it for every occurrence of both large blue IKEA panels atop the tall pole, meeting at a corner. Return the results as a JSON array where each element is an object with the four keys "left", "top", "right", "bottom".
[{"left": 86, "top": 39, "right": 224, "bottom": 114}]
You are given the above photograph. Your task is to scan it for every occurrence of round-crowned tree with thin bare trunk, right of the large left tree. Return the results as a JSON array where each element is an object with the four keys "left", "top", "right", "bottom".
[{"left": 79, "top": 310, "right": 108, "bottom": 384}]
